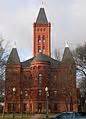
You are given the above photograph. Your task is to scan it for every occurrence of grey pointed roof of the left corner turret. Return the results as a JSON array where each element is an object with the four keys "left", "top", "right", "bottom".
[{"left": 7, "top": 48, "right": 20, "bottom": 64}]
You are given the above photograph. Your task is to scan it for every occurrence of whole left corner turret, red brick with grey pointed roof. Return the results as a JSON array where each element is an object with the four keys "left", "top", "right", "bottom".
[{"left": 5, "top": 48, "right": 21, "bottom": 112}]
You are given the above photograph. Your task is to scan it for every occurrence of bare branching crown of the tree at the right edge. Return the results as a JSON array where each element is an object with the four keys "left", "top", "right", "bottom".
[{"left": 73, "top": 43, "right": 86, "bottom": 94}]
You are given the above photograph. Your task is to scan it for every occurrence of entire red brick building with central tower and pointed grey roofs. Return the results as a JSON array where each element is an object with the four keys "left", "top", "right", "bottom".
[{"left": 5, "top": 8, "right": 77, "bottom": 113}]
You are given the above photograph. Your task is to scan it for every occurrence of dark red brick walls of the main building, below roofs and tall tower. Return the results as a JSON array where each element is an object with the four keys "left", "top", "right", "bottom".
[{"left": 5, "top": 62, "right": 77, "bottom": 112}]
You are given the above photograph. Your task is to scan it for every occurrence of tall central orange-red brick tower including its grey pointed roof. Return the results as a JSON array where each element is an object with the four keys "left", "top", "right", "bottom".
[{"left": 33, "top": 8, "right": 51, "bottom": 56}]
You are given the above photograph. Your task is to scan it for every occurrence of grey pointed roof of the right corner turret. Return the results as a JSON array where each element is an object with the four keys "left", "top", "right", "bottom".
[{"left": 62, "top": 47, "right": 75, "bottom": 63}]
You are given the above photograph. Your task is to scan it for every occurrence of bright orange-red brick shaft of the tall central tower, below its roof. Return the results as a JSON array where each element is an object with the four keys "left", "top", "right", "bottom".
[{"left": 33, "top": 23, "right": 51, "bottom": 56}]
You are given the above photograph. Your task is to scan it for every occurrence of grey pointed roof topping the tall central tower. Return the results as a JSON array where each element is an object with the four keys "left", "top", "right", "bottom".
[{"left": 36, "top": 8, "right": 48, "bottom": 24}]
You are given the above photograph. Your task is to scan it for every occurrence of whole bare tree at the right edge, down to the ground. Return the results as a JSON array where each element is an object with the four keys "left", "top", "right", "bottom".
[{"left": 73, "top": 43, "right": 86, "bottom": 111}]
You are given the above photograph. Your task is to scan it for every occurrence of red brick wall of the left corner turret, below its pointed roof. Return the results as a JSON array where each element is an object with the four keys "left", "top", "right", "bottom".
[{"left": 5, "top": 65, "right": 20, "bottom": 112}]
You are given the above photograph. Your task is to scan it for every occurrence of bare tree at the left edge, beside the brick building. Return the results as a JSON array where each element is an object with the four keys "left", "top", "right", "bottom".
[{"left": 0, "top": 37, "right": 9, "bottom": 102}]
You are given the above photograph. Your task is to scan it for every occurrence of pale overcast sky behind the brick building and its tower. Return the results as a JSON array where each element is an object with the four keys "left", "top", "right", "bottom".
[{"left": 0, "top": 0, "right": 86, "bottom": 59}]
